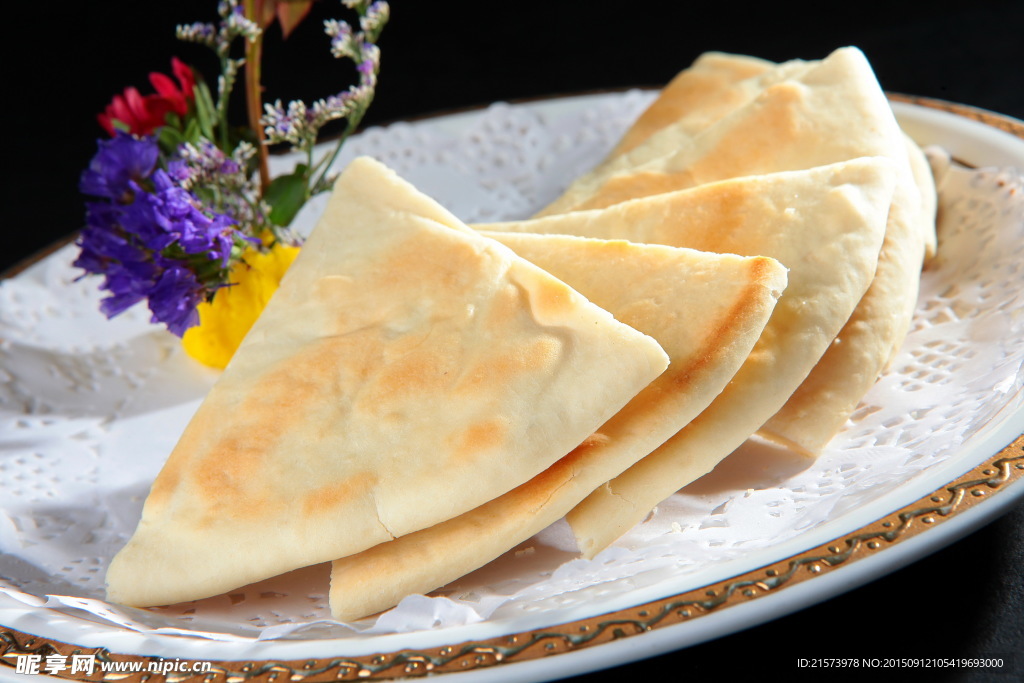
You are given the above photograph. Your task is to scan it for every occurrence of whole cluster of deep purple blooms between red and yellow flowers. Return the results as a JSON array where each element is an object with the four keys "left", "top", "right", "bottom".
[{"left": 75, "top": 134, "right": 258, "bottom": 335}]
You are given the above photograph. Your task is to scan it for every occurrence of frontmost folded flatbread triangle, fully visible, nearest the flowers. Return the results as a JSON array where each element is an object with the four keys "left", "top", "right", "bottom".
[{"left": 106, "top": 158, "right": 668, "bottom": 606}]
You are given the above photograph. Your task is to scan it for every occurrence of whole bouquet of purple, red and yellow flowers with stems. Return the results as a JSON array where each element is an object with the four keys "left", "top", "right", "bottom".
[{"left": 75, "top": 0, "right": 389, "bottom": 368}]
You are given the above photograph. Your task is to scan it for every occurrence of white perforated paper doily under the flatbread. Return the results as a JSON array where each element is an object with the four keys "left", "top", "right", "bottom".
[{"left": 0, "top": 91, "right": 1024, "bottom": 642}]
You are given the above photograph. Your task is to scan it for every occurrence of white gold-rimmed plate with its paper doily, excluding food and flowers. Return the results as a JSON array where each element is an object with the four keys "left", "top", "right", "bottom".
[{"left": 0, "top": 91, "right": 1024, "bottom": 681}]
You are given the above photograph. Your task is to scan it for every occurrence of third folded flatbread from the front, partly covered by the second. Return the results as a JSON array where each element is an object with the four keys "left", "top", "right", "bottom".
[{"left": 489, "top": 158, "right": 895, "bottom": 555}]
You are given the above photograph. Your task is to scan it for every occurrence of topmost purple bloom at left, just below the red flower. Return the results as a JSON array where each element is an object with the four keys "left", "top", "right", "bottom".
[{"left": 79, "top": 131, "right": 160, "bottom": 202}]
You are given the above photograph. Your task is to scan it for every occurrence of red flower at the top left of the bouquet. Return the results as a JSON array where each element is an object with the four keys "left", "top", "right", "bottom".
[{"left": 96, "top": 57, "right": 196, "bottom": 135}]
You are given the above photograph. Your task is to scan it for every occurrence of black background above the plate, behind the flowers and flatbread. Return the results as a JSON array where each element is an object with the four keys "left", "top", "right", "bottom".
[{"left": 6, "top": 0, "right": 1024, "bottom": 268}]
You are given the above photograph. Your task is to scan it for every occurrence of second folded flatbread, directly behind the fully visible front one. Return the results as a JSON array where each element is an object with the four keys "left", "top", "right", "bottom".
[{"left": 331, "top": 232, "right": 786, "bottom": 621}]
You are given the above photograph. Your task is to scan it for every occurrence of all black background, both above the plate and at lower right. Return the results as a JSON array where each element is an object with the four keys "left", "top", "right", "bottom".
[{"left": 0, "top": 0, "right": 1024, "bottom": 681}]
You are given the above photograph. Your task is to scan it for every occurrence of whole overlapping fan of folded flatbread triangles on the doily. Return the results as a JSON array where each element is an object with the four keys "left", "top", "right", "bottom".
[{"left": 108, "top": 48, "right": 934, "bottom": 620}]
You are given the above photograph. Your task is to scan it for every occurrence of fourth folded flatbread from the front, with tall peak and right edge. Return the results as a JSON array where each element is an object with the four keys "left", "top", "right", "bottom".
[{"left": 539, "top": 47, "right": 935, "bottom": 456}]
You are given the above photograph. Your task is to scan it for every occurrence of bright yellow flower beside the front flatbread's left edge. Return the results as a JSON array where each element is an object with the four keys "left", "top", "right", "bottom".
[{"left": 181, "top": 244, "right": 299, "bottom": 369}]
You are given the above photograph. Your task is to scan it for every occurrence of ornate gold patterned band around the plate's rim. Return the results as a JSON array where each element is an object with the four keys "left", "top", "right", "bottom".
[{"left": 0, "top": 93, "right": 1024, "bottom": 683}]
